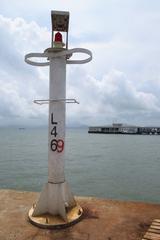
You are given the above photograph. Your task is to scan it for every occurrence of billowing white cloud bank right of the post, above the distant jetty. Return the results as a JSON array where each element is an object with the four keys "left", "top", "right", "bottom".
[{"left": 66, "top": 69, "right": 160, "bottom": 125}]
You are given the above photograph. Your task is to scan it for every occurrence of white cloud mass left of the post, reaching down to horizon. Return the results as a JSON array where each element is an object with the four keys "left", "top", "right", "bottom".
[{"left": 0, "top": 16, "right": 48, "bottom": 125}]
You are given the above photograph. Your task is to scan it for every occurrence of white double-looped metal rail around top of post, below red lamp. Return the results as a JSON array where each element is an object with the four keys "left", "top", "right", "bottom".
[{"left": 25, "top": 48, "right": 92, "bottom": 66}]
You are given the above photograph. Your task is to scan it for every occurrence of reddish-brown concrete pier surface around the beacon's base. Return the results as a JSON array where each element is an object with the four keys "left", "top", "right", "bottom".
[{"left": 0, "top": 190, "right": 160, "bottom": 240}]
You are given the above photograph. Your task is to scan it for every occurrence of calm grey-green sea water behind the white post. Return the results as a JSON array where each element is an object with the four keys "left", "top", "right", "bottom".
[{"left": 0, "top": 128, "right": 160, "bottom": 202}]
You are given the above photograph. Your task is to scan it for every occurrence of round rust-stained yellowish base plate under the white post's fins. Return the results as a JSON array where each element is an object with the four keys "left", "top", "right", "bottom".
[{"left": 28, "top": 204, "right": 83, "bottom": 229}]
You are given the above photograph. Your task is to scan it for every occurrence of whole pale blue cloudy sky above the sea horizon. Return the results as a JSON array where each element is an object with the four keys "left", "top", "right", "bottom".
[{"left": 0, "top": 0, "right": 160, "bottom": 126}]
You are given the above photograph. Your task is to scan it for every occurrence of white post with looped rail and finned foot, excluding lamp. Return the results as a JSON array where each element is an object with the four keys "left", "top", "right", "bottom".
[{"left": 25, "top": 48, "right": 92, "bottom": 222}]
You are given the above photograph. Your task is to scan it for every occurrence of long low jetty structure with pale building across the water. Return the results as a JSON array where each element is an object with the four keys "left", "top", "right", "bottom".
[{"left": 88, "top": 123, "right": 160, "bottom": 135}]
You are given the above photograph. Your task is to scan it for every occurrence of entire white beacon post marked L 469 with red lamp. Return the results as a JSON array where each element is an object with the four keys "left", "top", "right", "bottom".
[{"left": 25, "top": 11, "right": 92, "bottom": 228}]
